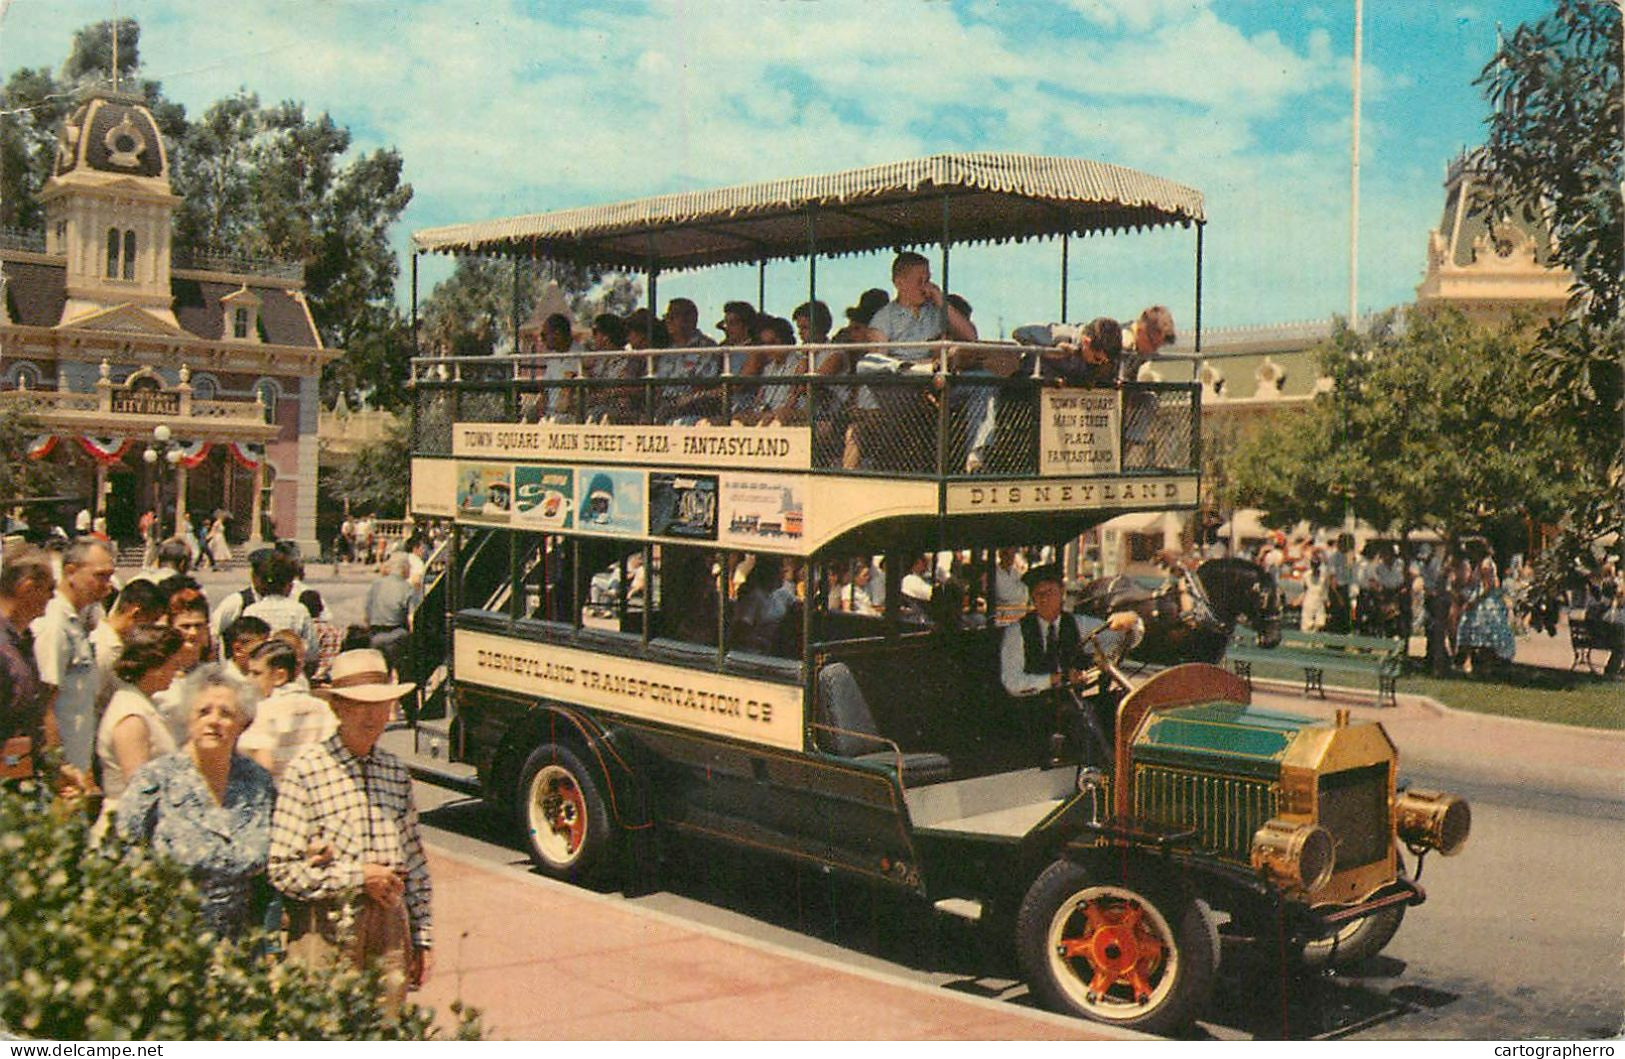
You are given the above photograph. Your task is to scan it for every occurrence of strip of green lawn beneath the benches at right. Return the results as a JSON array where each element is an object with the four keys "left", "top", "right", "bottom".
[{"left": 1253, "top": 658, "right": 1625, "bottom": 729}]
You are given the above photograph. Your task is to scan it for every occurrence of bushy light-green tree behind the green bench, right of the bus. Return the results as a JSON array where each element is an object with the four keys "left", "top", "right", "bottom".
[{"left": 1229, "top": 309, "right": 1584, "bottom": 538}]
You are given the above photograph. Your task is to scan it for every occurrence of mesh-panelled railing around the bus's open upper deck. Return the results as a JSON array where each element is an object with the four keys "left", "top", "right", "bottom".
[{"left": 413, "top": 343, "right": 1201, "bottom": 478}]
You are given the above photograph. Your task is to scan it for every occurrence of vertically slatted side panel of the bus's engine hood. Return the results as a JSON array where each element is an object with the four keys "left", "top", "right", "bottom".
[{"left": 1134, "top": 765, "right": 1281, "bottom": 862}]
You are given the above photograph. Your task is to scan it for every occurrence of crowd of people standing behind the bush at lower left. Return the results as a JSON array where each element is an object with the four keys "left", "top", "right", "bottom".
[{"left": 0, "top": 534, "right": 431, "bottom": 1005}]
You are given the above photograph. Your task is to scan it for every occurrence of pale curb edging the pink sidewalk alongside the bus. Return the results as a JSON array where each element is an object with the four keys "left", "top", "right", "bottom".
[{"left": 424, "top": 841, "right": 1164, "bottom": 1041}]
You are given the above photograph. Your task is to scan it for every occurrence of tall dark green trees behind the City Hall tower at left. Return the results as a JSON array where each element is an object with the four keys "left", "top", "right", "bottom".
[{"left": 0, "top": 19, "right": 413, "bottom": 403}]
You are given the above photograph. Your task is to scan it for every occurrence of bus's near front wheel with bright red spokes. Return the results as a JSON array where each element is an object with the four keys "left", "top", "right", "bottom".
[{"left": 1016, "top": 861, "right": 1217, "bottom": 1033}]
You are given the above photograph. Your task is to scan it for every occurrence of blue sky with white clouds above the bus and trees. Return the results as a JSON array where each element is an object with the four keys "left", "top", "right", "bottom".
[{"left": 0, "top": 0, "right": 1549, "bottom": 335}]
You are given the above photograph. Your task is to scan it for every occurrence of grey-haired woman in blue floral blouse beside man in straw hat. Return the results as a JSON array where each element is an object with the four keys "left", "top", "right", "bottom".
[{"left": 119, "top": 666, "right": 276, "bottom": 937}]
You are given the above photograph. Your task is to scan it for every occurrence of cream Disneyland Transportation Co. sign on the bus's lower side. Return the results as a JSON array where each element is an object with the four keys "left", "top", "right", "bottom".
[{"left": 453, "top": 629, "right": 803, "bottom": 750}]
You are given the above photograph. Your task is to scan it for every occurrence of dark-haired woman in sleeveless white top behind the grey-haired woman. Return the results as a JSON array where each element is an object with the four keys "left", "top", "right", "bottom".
[{"left": 96, "top": 625, "right": 187, "bottom": 807}]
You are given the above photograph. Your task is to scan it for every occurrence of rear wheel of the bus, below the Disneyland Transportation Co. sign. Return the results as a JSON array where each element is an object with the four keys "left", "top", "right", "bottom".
[{"left": 515, "top": 742, "right": 613, "bottom": 882}]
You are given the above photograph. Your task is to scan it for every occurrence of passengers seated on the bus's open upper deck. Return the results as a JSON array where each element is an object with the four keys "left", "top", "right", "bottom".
[{"left": 500, "top": 252, "right": 1175, "bottom": 473}]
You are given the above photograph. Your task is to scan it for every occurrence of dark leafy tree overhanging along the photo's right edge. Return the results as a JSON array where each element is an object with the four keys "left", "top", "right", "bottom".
[{"left": 1477, "top": 0, "right": 1625, "bottom": 551}]
